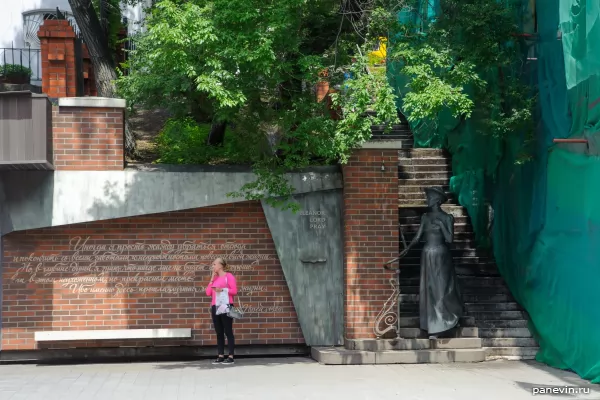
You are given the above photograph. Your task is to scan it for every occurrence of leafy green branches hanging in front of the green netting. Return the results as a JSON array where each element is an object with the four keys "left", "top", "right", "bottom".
[{"left": 389, "top": 0, "right": 535, "bottom": 145}]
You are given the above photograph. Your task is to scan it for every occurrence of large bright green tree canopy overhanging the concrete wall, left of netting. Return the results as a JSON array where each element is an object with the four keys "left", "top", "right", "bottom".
[{"left": 119, "top": 0, "right": 397, "bottom": 211}]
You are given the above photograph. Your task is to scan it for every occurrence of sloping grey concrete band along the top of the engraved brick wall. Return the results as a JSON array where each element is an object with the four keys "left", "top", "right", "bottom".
[{"left": 0, "top": 166, "right": 342, "bottom": 234}]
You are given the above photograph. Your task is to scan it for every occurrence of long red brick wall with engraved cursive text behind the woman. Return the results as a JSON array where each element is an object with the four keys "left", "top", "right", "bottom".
[{"left": 2, "top": 202, "right": 304, "bottom": 350}]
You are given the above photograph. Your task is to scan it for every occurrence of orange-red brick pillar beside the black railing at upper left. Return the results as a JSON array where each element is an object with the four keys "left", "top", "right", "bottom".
[{"left": 37, "top": 19, "right": 77, "bottom": 98}]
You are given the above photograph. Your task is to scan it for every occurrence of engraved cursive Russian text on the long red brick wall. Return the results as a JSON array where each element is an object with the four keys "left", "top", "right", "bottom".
[{"left": 10, "top": 236, "right": 282, "bottom": 314}]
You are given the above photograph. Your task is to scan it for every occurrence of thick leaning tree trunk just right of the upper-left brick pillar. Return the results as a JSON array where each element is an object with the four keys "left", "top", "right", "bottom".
[{"left": 69, "top": 0, "right": 136, "bottom": 155}]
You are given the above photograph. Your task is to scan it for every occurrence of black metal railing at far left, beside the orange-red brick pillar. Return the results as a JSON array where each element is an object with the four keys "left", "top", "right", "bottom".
[{"left": 0, "top": 47, "right": 42, "bottom": 86}]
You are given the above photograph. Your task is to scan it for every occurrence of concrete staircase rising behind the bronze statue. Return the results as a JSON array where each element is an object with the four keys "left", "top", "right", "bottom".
[{"left": 398, "top": 149, "right": 538, "bottom": 360}]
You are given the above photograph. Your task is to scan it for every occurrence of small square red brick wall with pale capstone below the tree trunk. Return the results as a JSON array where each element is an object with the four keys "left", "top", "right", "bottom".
[{"left": 52, "top": 107, "right": 125, "bottom": 171}]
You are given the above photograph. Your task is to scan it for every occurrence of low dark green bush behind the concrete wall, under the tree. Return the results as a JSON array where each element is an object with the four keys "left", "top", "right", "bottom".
[{"left": 156, "top": 118, "right": 259, "bottom": 165}]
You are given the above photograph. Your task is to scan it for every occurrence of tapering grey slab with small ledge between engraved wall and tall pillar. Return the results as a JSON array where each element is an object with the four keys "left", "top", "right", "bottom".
[{"left": 263, "top": 190, "right": 344, "bottom": 346}]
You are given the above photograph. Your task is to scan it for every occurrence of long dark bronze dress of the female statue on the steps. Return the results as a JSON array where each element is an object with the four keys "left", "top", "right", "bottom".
[{"left": 419, "top": 216, "right": 464, "bottom": 335}]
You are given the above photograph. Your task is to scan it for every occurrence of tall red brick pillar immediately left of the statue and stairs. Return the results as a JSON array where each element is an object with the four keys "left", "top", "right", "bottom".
[{"left": 342, "top": 142, "right": 400, "bottom": 339}]
